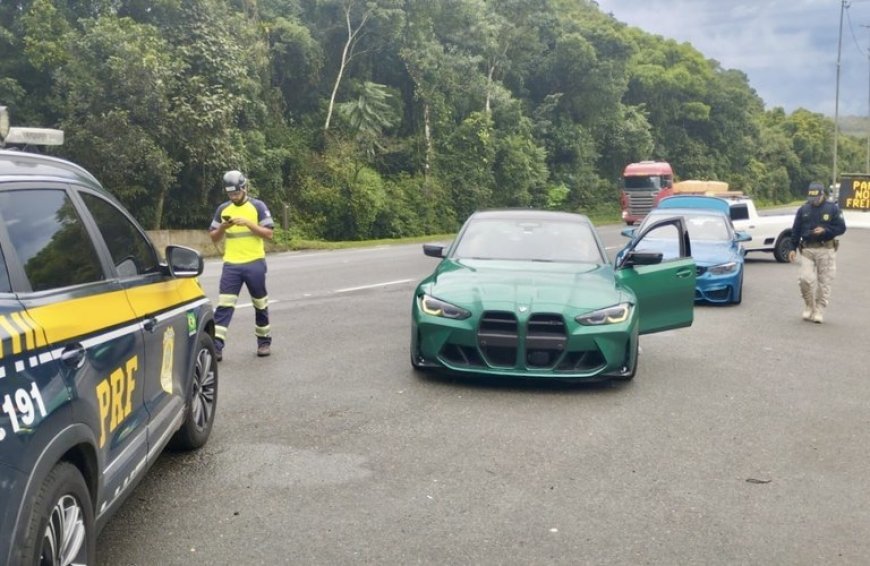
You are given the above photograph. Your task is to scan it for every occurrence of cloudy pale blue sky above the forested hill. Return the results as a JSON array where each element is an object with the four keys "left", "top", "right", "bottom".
[{"left": 597, "top": 0, "right": 870, "bottom": 117}]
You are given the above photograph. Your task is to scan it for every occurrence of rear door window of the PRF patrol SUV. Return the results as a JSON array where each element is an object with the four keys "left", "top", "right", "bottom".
[{"left": 0, "top": 189, "right": 105, "bottom": 291}]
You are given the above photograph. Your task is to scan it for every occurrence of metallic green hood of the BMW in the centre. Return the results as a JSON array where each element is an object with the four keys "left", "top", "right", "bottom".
[{"left": 421, "top": 259, "right": 633, "bottom": 312}]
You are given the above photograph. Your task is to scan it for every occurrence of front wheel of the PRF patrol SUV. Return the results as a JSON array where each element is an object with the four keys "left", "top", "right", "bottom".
[{"left": 171, "top": 333, "right": 218, "bottom": 450}]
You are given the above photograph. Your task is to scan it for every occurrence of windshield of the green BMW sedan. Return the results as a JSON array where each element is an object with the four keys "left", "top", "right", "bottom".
[{"left": 451, "top": 218, "right": 606, "bottom": 264}]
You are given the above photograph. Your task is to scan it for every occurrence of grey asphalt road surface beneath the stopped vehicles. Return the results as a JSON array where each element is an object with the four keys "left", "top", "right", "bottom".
[{"left": 98, "top": 222, "right": 870, "bottom": 566}]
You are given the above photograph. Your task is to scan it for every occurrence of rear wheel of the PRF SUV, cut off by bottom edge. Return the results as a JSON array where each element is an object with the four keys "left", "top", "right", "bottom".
[{"left": 21, "top": 462, "right": 96, "bottom": 566}]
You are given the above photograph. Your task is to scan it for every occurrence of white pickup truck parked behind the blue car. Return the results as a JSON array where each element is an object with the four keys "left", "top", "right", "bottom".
[{"left": 722, "top": 196, "right": 794, "bottom": 263}]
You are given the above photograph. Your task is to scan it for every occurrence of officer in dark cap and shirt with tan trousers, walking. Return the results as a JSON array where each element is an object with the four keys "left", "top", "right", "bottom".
[{"left": 788, "top": 183, "right": 846, "bottom": 324}]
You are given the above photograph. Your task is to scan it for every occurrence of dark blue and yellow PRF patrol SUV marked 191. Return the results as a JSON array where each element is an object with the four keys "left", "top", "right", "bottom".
[{"left": 0, "top": 150, "right": 218, "bottom": 566}]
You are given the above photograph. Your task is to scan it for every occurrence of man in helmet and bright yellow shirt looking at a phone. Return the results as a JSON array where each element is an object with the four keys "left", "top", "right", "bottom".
[{"left": 209, "top": 171, "right": 274, "bottom": 361}]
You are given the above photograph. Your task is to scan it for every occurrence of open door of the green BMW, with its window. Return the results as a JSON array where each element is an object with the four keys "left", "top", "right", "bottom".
[{"left": 614, "top": 217, "right": 695, "bottom": 334}]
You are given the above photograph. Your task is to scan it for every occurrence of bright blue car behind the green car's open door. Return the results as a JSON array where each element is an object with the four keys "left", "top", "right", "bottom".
[{"left": 620, "top": 199, "right": 752, "bottom": 304}]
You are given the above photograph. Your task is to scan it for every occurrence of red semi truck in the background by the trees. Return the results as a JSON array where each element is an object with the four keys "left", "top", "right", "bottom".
[{"left": 620, "top": 161, "right": 674, "bottom": 225}]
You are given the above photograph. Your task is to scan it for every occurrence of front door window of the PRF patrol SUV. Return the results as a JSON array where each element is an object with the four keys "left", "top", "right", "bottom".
[{"left": 82, "top": 193, "right": 159, "bottom": 277}]
